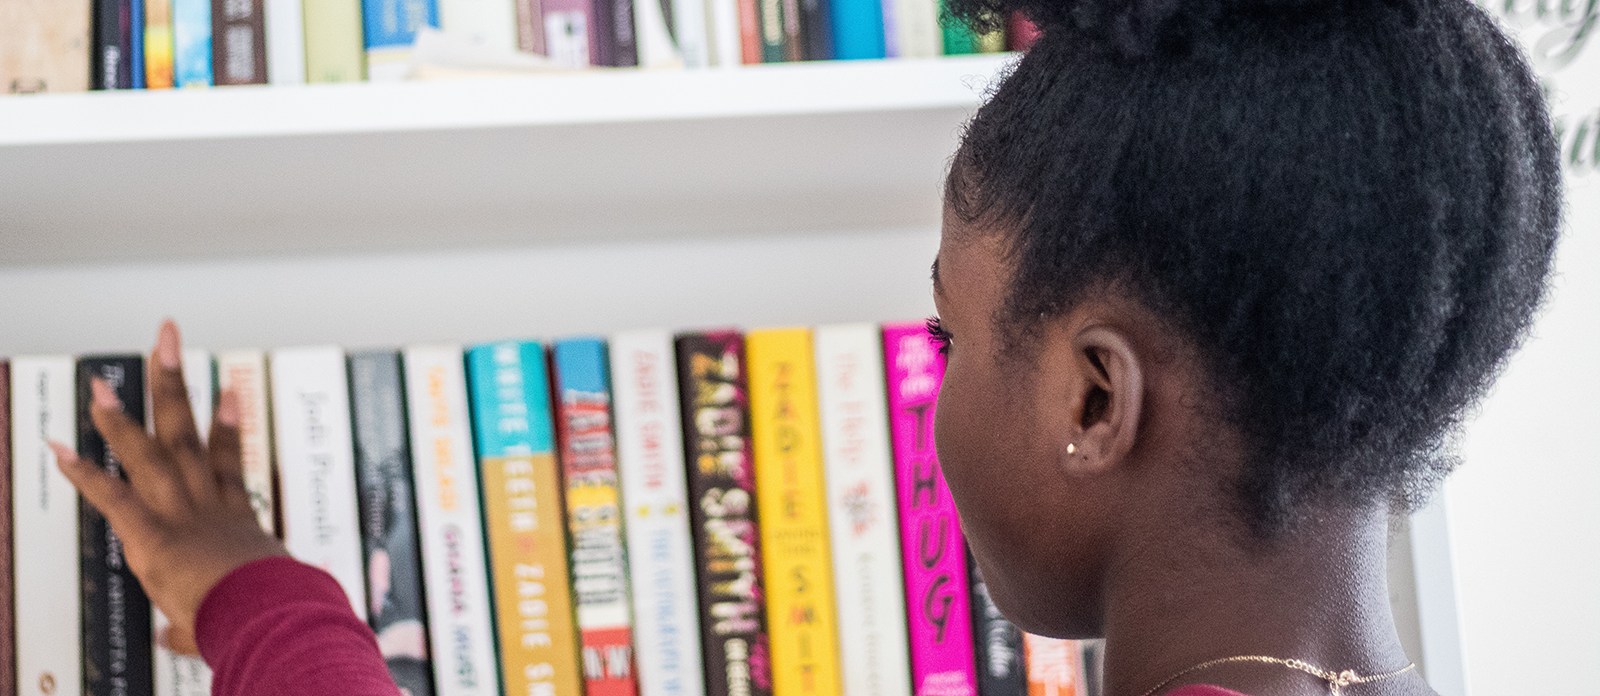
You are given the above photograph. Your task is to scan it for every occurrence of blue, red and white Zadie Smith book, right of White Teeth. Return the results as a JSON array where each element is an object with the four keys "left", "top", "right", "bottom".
[{"left": 550, "top": 339, "right": 638, "bottom": 696}]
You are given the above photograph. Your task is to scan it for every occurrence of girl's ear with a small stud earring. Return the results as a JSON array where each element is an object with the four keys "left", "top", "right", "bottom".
[{"left": 1059, "top": 325, "right": 1144, "bottom": 475}]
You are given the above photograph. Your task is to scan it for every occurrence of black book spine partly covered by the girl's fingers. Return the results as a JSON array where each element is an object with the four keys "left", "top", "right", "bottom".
[{"left": 77, "top": 355, "right": 154, "bottom": 696}]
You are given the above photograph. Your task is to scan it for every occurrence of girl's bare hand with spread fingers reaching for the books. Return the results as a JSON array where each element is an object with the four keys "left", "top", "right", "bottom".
[{"left": 51, "top": 320, "right": 288, "bottom": 654}]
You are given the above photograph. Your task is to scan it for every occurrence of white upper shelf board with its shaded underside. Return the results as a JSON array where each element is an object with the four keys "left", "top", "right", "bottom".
[{"left": 0, "top": 54, "right": 1014, "bottom": 266}]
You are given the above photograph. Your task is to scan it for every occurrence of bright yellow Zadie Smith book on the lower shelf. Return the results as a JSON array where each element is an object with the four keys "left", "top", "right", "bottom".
[{"left": 746, "top": 328, "right": 840, "bottom": 696}]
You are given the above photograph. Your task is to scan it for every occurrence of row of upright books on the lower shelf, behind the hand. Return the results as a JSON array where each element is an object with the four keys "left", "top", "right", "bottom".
[{"left": 0, "top": 323, "right": 1096, "bottom": 696}]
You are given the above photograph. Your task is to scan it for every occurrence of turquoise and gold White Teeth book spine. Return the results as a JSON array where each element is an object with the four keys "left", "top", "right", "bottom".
[{"left": 467, "top": 341, "right": 582, "bottom": 696}]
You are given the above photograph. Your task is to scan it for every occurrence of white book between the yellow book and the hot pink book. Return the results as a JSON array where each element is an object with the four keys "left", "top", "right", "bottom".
[{"left": 816, "top": 323, "right": 912, "bottom": 696}]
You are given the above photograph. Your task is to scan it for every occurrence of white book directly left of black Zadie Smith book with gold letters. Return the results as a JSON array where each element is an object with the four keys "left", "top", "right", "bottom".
[{"left": 611, "top": 331, "right": 704, "bottom": 696}]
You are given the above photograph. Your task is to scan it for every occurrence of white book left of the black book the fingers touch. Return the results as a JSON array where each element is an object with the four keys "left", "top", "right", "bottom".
[{"left": 10, "top": 355, "right": 83, "bottom": 696}]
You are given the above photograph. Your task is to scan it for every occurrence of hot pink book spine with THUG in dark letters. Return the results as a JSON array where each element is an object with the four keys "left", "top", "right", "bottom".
[{"left": 883, "top": 323, "right": 978, "bottom": 696}]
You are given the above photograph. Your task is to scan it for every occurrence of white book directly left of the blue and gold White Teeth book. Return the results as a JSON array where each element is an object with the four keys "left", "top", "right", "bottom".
[{"left": 403, "top": 346, "right": 499, "bottom": 696}]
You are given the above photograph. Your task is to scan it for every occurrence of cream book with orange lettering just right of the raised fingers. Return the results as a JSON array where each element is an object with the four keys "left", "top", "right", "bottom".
[{"left": 216, "top": 350, "right": 282, "bottom": 536}]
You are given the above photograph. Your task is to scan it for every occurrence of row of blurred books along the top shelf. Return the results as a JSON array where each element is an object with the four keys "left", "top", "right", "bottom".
[{"left": 0, "top": 0, "right": 1035, "bottom": 93}]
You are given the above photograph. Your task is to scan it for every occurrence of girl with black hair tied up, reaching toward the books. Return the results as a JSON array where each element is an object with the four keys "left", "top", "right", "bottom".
[{"left": 58, "top": 0, "right": 1560, "bottom": 696}]
